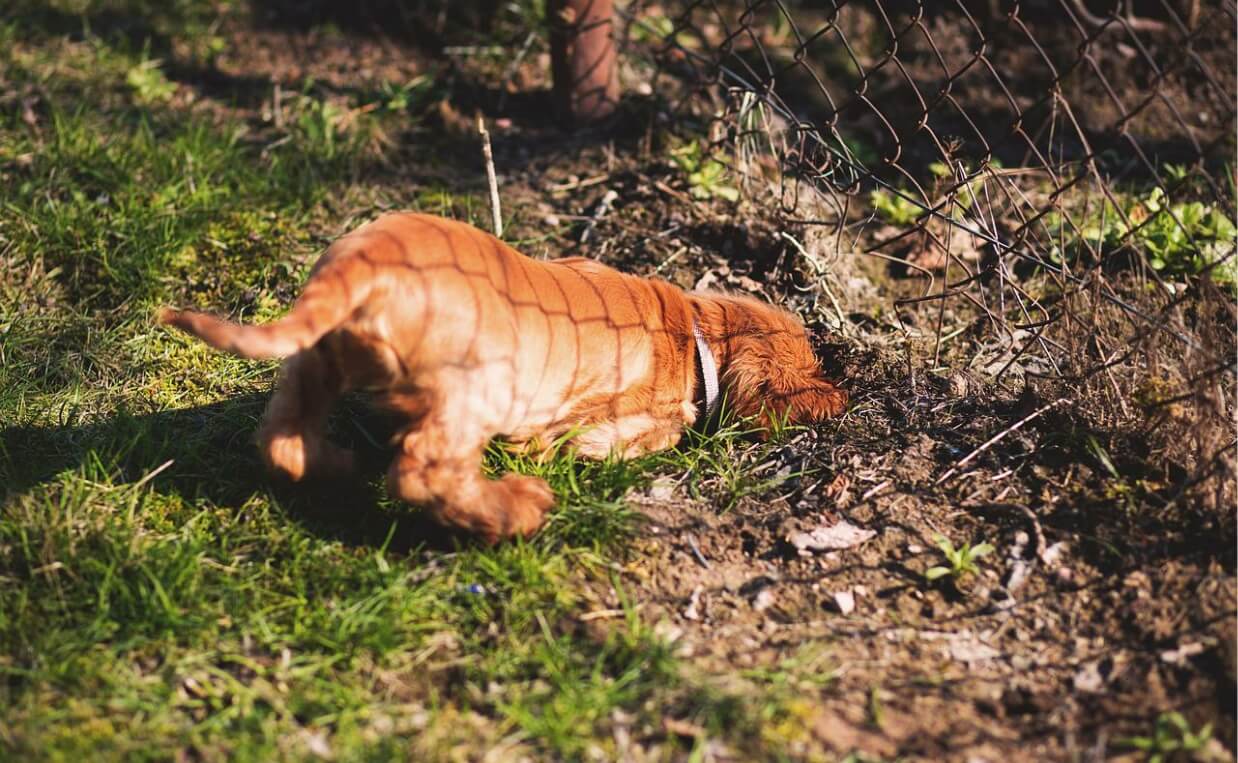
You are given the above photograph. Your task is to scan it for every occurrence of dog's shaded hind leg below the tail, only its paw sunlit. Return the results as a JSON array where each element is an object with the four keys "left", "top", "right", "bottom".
[{"left": 258, "top": 347, "right": 353, "bottom": 481}]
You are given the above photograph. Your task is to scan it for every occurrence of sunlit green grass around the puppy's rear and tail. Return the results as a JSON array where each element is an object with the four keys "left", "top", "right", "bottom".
[{"left": 0, "top": 6, "right": 831, "bottom": 759}]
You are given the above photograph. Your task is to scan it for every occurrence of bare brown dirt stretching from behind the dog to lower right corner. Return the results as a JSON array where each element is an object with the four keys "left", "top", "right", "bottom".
[{"left": 67, "top": 2, "right": 1238, "bottom": 761}]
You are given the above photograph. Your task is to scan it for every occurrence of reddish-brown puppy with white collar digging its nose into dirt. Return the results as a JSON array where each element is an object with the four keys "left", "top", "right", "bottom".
[{"left": 160, "top": 214, "right": 847, "bottom": 543}]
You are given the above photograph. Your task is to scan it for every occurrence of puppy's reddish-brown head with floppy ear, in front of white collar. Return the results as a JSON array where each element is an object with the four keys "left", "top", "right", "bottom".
[{"left": 693, "top": 295, "right": 847, "bottom": 427}]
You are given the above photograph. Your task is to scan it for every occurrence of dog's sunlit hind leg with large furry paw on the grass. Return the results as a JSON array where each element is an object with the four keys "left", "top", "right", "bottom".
[{"left": 387, "top": 419, "right": 555, "bottom": 544}]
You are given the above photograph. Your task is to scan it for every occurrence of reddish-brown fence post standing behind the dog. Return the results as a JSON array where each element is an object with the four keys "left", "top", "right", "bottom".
[{"left": 547, "top": 0, "right": 619, "bottom": 124}]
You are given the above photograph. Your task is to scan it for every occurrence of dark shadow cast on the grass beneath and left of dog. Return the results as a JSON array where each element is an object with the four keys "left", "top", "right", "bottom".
[{"left": 0, "top": 394, "right": 470, "bottom": 554}]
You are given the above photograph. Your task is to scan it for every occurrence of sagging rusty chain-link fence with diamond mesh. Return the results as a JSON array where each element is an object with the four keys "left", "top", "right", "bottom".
[{"left": 618, "top": 0, "right": 1238, "bottom": 379}]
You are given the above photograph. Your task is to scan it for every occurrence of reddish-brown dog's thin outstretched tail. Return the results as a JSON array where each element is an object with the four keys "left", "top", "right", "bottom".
[{"left": 158, "top": 263, "right": 371, "bottom": 358}]
